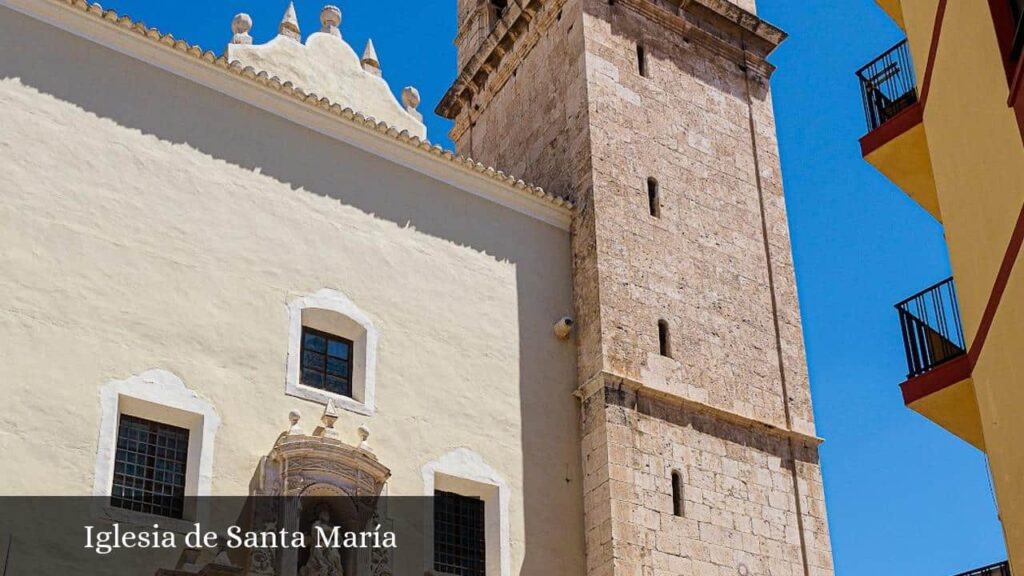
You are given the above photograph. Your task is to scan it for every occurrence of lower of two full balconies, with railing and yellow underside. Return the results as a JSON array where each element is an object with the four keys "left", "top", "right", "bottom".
[{"left": 896, "top": 278, "right": 985, "bottom": 450}]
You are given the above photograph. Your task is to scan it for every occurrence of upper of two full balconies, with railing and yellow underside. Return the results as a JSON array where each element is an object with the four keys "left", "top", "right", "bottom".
[{"left": 857, "top": 40, "right": 941, "bottom": 218}]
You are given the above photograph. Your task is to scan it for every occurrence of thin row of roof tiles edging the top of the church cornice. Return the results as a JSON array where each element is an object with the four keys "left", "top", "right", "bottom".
[{"left": 34, "top": 0, "right": 574, "bottom": 217}]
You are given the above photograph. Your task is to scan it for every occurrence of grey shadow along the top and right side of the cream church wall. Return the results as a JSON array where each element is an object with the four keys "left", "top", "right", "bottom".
[{"left": 0, "top": 7, "right": 583, "bottom": 574}]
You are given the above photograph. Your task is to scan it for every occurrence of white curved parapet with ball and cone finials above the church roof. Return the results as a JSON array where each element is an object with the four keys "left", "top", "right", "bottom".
[{"left": 226, "top": 3, "right": 427, "bottom": 137}]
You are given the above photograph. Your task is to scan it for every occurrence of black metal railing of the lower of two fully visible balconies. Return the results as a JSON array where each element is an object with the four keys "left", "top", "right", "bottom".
[{"left": 896, "top": 278, "right": 966, "bottom": 378}]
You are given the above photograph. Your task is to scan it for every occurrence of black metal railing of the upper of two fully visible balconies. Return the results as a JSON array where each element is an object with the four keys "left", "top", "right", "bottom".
[{"left": 857, "top": 40, "right": 918, "bottom": 131}]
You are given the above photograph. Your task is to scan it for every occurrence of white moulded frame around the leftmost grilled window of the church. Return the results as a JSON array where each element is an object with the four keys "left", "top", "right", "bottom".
[{"left": 92, "top": 370, "right": 220, "bottom": 532}]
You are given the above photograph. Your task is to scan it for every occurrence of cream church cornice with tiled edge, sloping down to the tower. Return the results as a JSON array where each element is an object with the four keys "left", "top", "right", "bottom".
[{"left": 0, "top": 0, "right": 573, "bottom": 230}]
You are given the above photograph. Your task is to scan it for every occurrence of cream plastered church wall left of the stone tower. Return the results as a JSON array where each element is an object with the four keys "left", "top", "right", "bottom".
[{"left": 0, "top": 8, "right": 583, "bottom": 574}]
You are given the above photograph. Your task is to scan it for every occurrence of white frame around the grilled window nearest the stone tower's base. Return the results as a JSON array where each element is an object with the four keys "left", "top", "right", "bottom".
[{"left": 422, "top": 448, "right": 512, "bottom": 576}]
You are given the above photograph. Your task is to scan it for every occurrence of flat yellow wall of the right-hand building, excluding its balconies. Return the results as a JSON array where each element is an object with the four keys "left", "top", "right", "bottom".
[{"left": 902, "top": 0, "right": 1024, "bottom": 572}]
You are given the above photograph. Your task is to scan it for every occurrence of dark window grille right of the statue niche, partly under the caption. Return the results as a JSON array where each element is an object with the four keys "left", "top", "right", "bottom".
[{"left": 434, "top": 490, "right": 486, "bottom": 576}]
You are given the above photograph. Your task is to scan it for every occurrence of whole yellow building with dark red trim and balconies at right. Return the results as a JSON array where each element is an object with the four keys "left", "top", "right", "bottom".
[{"left": 857, "top": 0, "right": 1024, "bottom": 574}]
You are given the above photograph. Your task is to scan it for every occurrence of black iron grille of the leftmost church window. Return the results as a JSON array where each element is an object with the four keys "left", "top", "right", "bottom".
[{"left": 111, "top": 414, "right": 188, "bottom": 518}]
